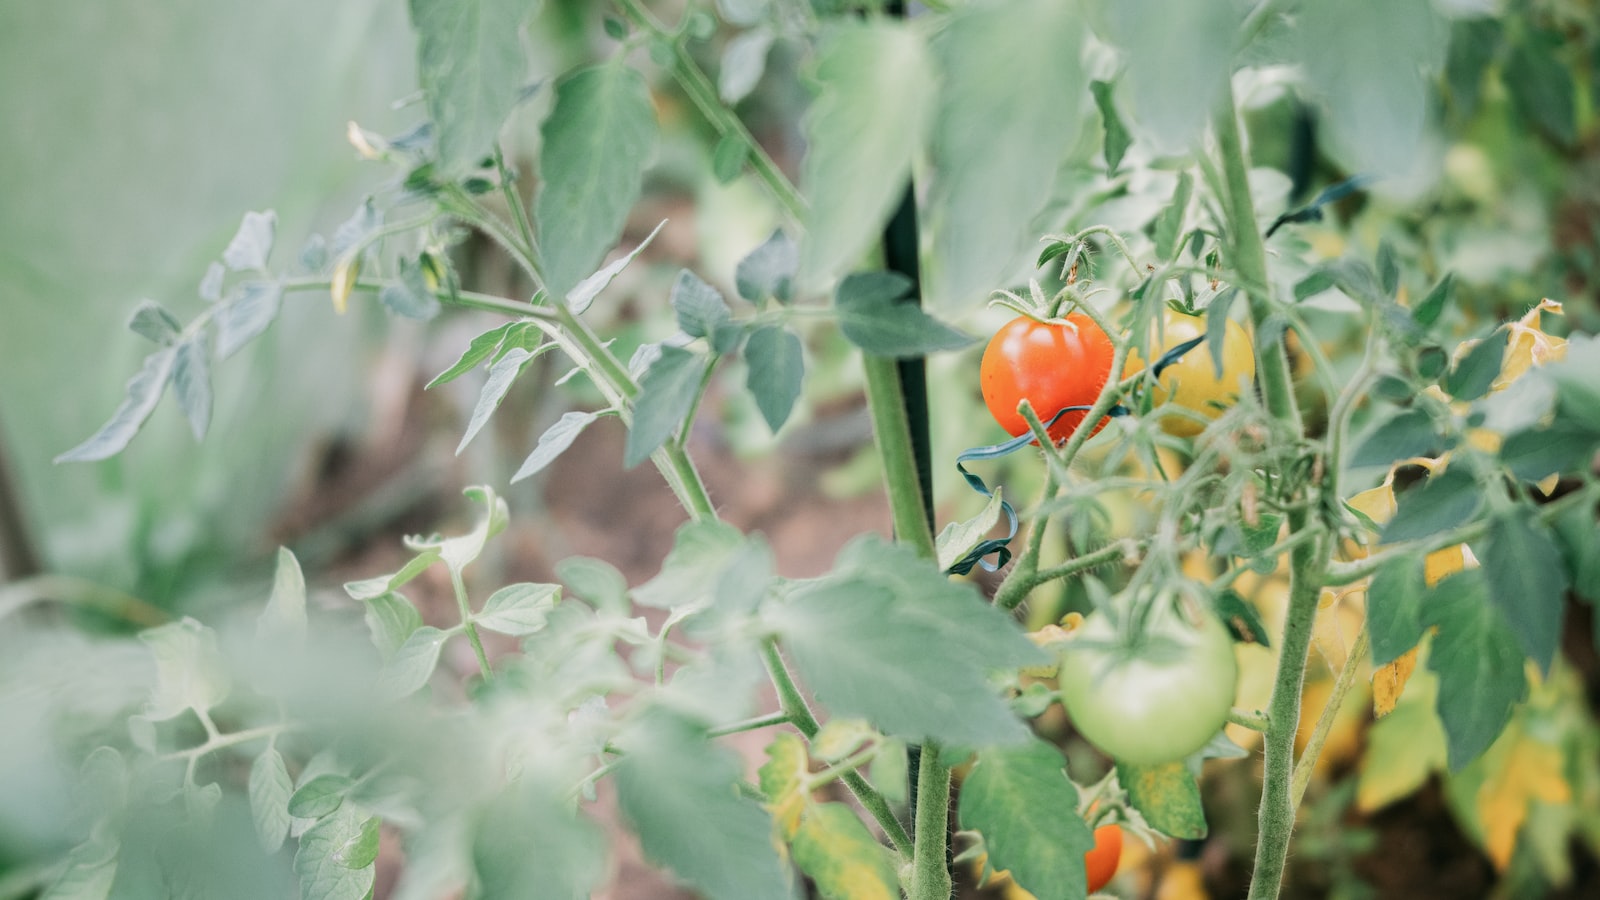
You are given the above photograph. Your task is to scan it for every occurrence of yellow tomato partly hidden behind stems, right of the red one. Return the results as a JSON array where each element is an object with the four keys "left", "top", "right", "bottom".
[{"left": 1123, "top": 309, "right": 1256, "bottom": 437}]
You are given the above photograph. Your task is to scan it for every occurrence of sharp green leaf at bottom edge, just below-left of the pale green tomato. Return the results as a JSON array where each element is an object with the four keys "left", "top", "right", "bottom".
[{"left": 958, "top": 738, "right": 1094, "bottom": 900}]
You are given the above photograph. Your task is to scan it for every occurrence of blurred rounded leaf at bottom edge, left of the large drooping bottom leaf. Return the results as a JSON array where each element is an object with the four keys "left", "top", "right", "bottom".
[{"left": 472, "top": 777, "right": 606, "bottom": 900}]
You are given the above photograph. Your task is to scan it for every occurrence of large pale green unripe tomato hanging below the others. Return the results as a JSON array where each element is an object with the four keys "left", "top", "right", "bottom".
[{"left": 1059, "top": 599, "right": 1238, "bottom": 764}]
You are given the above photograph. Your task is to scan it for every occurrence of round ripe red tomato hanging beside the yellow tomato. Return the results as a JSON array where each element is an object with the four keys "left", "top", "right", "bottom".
[{"left": 978, "top": 312, "right": 1115, "bottom": 444}]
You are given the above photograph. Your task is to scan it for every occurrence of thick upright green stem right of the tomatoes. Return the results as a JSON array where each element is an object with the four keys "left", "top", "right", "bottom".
[{"left": 1216, "top": 84, "right": 1338, "bottom": 900}]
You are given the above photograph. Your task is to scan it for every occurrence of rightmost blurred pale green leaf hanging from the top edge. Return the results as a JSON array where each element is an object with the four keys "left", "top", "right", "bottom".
[{"left": 1299, "top": 0, "right": 1448, "bottom": 176}]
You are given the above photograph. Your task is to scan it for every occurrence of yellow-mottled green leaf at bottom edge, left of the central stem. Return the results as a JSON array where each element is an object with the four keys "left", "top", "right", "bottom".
[{"left": 794, "top": 802, "right": 901, "bottom": 900}]
